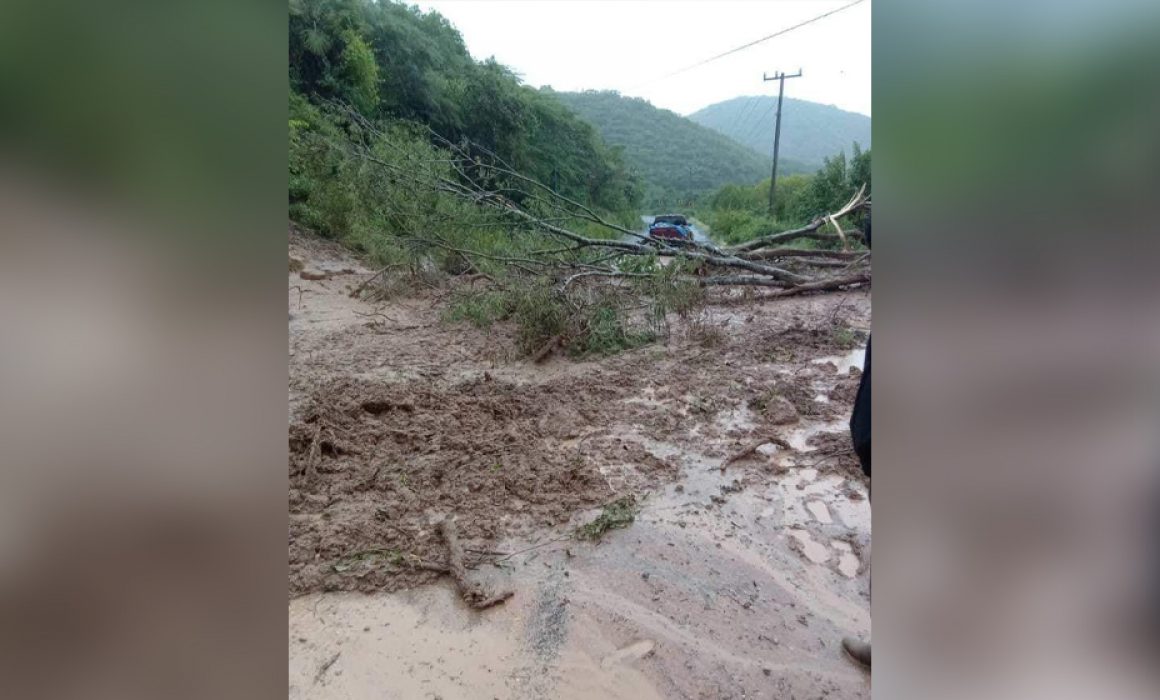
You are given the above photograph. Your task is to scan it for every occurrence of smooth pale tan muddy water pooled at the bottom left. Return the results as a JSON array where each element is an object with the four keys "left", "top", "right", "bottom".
[{"left": 289, "top": 585, "right": 661, "bottom": 700}]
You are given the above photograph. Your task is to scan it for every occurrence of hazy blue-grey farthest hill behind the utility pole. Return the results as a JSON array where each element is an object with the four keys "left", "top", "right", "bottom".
[{"left": 689, "top": 96, "right": 870, "bottom": 166}]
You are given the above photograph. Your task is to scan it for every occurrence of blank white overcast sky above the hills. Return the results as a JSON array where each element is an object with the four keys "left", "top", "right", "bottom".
[{"left": 418, "top": 0, "right": 871, "bottom": 115}]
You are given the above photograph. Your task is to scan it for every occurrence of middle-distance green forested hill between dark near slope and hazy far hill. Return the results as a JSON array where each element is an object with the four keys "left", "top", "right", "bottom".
[{"left": 544, "top": 88, "right": 807, "bottom": 206}]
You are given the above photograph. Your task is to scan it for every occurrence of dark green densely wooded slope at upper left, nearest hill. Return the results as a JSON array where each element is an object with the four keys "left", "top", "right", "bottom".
[{"left": 289, "top": 0, "right": 640, "bottom": 218}]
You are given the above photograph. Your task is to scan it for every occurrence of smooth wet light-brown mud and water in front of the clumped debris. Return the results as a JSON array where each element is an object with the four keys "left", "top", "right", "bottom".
[{"left": 290, "top": 426, "right": 869, "bottom": 700}]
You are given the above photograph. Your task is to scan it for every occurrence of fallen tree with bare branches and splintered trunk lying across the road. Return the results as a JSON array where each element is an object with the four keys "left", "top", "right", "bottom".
[{"left": 335, "top": 106, "right": 870, "bottom": 296}]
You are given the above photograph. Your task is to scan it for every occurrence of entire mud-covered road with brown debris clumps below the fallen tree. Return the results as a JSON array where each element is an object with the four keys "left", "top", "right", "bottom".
[{"left": 289, "top": 232, "right": 870, "bottom": 699}]
